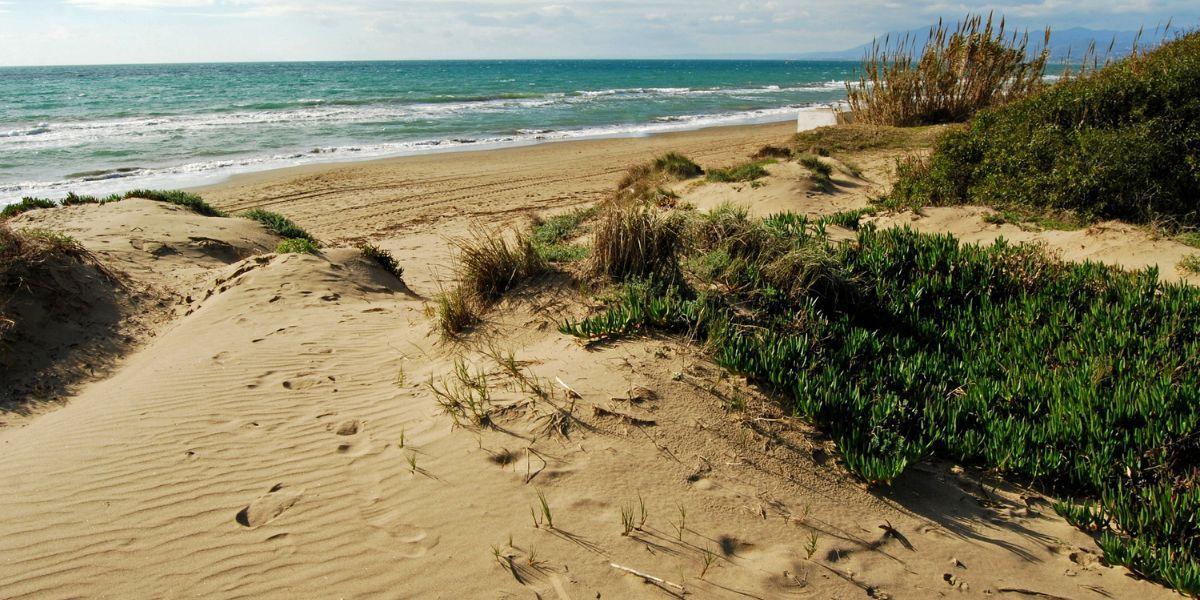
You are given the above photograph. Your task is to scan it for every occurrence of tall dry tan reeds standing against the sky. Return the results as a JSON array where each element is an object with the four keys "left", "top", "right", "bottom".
[{"left": 846, "top": 14, "right": 1050, "bottom": 126}]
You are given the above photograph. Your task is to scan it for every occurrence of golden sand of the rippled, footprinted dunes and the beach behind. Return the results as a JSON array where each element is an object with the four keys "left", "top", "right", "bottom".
[{"left": 0, "top": 126, "right": 1190, "bottom": 600}]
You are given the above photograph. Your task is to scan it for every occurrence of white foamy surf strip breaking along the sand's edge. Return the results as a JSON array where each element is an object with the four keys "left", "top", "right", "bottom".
[{"left": 0, "top": 106, "right": 833, "bottom": 204}]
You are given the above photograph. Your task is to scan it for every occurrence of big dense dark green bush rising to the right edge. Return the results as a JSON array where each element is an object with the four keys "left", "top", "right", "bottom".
[{"left": 890, "top": 34, "right": 1200, "bottom": 226}]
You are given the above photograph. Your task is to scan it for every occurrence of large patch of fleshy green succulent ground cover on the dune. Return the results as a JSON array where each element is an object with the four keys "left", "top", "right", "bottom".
[{"left": 562, "top": 208, "right": 1200, "bottom": 593}]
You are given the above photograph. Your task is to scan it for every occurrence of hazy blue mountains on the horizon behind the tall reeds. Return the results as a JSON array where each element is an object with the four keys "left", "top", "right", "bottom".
[{"left": 793, "top": 28, "right": 1159, "bottom": 61}]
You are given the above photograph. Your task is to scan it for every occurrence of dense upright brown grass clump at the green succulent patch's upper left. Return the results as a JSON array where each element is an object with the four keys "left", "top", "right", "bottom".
[{"left": 592, "top": 203, "right": 684, "bottom": 281}]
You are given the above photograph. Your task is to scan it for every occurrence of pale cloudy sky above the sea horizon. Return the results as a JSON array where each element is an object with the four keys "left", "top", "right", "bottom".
[{"left": 0, "top": 0, "right": 1200, "bottom": 65}]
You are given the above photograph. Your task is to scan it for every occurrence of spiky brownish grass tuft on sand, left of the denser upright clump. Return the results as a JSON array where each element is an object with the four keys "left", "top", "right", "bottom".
[{"left": 455, "top": 227, "right": 546, "bottom": 304}]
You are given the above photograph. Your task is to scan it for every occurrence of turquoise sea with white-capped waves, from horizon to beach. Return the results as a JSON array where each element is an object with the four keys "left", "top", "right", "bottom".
[{"left": 0, "top": 60, "right": 853, "bottom": 204}]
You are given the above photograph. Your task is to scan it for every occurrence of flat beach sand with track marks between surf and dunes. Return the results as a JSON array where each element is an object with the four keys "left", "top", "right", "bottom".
[{"left": 190, "top": 119, "right": 811, "bottom": 241}]
